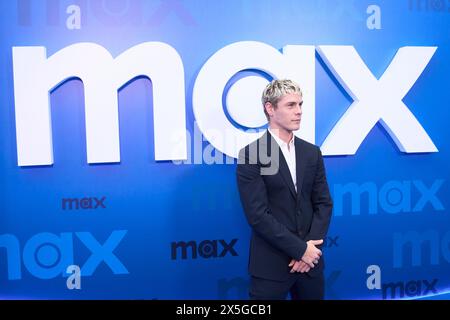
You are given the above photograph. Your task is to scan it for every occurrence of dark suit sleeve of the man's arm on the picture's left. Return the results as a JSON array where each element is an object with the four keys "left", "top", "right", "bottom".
[{"left": 237, "top": 149, "right": 307, "bottom": 260}]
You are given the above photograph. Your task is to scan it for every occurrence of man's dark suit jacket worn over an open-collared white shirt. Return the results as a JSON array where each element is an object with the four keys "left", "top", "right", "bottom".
[{"left": 236, "top": 131, "right": 333, "bottom": 281}]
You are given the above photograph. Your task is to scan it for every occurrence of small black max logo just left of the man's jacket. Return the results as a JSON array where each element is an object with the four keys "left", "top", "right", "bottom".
[{"left": 171, "top": 239, "right": 238, "bottom": 260}]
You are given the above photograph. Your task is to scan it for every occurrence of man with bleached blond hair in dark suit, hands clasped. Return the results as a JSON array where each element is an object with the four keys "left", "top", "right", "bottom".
[{"left": 236, "top": 80, "right": 333, "bottom": 300}]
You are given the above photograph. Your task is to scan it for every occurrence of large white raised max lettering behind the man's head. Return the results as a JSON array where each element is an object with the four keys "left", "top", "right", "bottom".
[{"left": 13, "top": 41, "right": 438, "bottom": 166}]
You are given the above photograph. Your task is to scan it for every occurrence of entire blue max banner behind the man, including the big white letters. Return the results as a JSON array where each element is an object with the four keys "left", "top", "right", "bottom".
[{"left": 0, "top": 0, "right": 450, "bottom": 299}]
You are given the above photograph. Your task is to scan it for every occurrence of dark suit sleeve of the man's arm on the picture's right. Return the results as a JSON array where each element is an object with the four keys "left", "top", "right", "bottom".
[{"left": 306, "top": 149, "right": 333, "bottom": 241}]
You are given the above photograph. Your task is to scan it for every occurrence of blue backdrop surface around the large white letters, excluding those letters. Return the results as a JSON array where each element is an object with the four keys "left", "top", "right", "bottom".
[{"left": 0, "top": 0, "right": 450, "bottom": 299}]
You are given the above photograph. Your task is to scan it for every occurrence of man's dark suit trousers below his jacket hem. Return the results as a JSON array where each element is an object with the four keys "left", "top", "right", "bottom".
[{"left": 250, "top": 272, "right": 325, "bottom": 300}]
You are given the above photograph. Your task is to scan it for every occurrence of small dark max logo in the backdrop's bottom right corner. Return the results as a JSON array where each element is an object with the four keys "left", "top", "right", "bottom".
[{"left": 382, "top": 279, "right": 438, "bottom": 299}]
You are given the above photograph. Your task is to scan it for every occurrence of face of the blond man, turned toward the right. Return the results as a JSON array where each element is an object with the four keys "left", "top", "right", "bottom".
[{"left": 266, "top": 93, "right": 303, "bottom": 132}]
